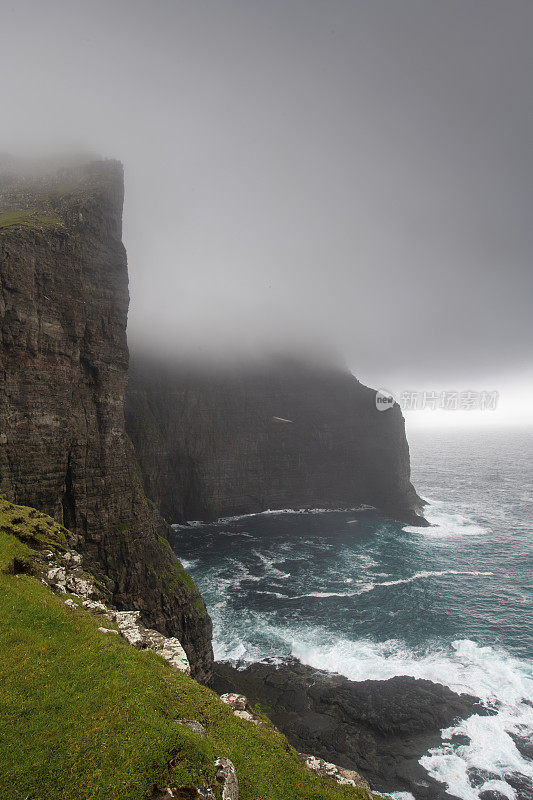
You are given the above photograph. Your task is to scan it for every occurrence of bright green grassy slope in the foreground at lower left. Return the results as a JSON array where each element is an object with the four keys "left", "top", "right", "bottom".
[{"left": 0, "top": 498, "right": 372, "bottom": 800}]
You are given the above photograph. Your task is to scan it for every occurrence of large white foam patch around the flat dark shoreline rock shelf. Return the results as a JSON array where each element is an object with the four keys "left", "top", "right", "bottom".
[{"left": 292, "top": 631, "right": 533, "bottom": 800}]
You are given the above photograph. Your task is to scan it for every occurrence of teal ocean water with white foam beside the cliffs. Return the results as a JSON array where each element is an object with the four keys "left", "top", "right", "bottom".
[{"left": 171, "top": 428, "right": 533, "bottom": 800}]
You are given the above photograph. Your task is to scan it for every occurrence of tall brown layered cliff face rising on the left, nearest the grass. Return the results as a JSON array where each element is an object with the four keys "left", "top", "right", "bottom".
[{"left": 0, "top": 162, "right": 212, "bottom": 680}]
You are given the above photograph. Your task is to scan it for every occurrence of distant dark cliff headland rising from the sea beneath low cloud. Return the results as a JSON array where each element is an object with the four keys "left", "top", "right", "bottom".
[{"left": 126, "top": 359, "right": 424, "bottom": 524}]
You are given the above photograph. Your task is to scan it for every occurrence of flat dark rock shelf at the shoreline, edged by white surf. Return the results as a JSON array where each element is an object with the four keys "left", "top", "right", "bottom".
[{"left": 215, "top": 660, "right": 486, "bottom": 800}]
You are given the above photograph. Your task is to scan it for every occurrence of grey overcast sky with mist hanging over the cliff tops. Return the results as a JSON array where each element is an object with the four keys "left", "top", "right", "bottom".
[{"left": 0, "top": 0, "right": 533, "bottom": 422}]
